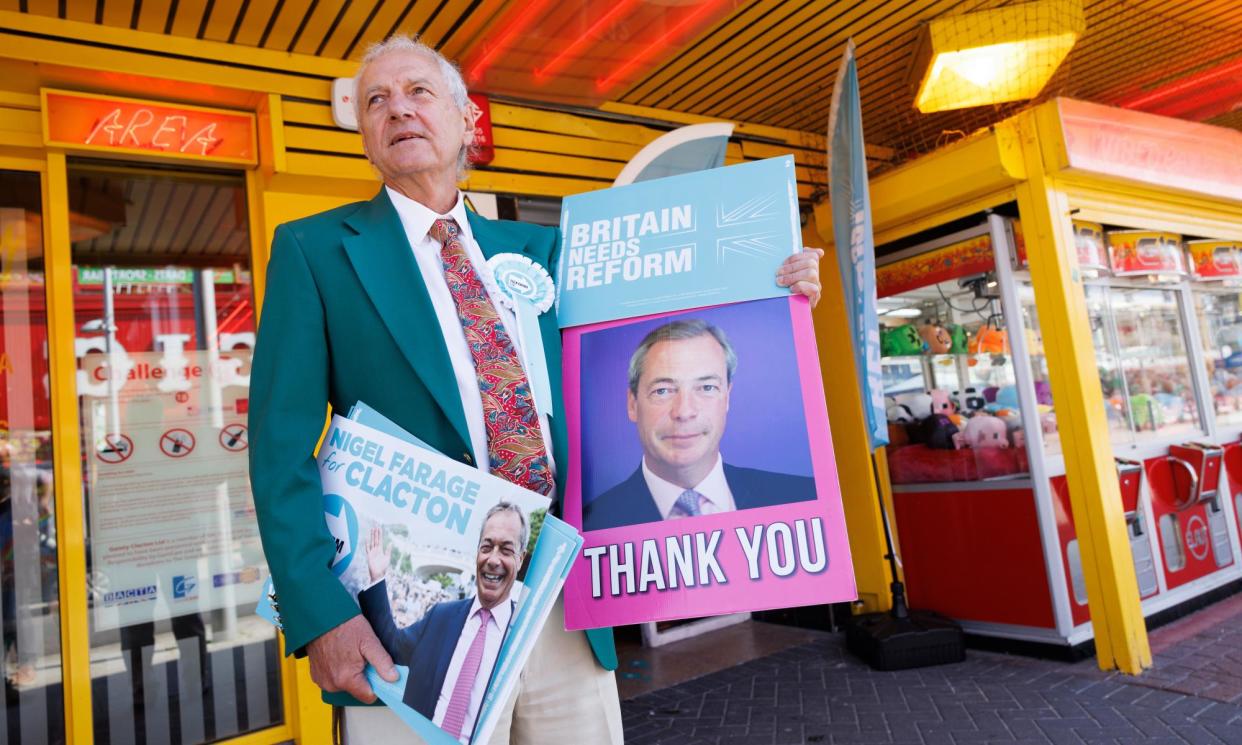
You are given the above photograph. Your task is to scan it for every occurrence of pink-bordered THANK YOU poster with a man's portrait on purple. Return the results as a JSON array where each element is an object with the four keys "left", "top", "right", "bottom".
[{"left": 564, "top": 297, "right": 857, "bottom": 630}]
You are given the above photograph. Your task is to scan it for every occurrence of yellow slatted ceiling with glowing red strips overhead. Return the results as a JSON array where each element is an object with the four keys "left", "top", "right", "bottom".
[{"left": 19, "top": 0, "right": 1242, "bottom": 166}]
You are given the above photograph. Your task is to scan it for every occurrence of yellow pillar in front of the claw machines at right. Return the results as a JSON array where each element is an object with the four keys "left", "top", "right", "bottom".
[{"left": 1011, "top": 106, "right": 1151, "bottom": 674}]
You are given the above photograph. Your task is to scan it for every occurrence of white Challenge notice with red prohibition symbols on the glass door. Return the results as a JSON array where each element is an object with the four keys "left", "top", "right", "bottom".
[{"left": 78, "top": 348, "right": 266, "bottom": 631}]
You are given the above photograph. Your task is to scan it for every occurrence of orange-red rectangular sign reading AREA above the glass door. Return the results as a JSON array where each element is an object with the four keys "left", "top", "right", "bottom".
[{"left": 42, "top": 88, "right": 257, "bottom": 165}]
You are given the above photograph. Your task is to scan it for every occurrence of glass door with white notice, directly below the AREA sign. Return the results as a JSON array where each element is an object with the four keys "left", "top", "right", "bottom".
[{"left": 68, "top": 161, "right": 283, "bottom": 745}]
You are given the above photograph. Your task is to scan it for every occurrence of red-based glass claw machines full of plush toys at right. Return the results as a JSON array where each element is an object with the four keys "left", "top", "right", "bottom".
[{"left": 877, "top": 214, "right": 1242, "bottom": 646}]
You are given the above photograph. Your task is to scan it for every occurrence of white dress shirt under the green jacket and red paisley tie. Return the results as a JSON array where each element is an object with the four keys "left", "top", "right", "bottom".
[{"left": 384, "top": 186, "right": 556, "bottom": 484}]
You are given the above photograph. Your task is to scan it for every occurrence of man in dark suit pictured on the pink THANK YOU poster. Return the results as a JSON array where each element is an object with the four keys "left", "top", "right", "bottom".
[{"left": 582, "top": 318, "right": 815, "bottom": 530}]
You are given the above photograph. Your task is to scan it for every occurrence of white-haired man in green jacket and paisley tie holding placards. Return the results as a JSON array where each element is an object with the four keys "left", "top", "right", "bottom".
[{"left": 250, "top": 36, "right": 820, "bottom": 744}]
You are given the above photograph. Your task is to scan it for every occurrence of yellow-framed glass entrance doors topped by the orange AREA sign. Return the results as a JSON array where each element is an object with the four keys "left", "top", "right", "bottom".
[{"left": 0, "top": 87, "right": 315, "bottom": 743}]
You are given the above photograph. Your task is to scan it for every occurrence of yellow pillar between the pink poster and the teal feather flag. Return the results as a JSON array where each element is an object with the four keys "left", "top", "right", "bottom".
[{"left": 802, "top": 202, "right": 893, "bottom": 612}]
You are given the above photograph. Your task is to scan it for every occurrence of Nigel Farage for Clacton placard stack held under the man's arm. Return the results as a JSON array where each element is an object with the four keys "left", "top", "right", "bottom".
[{"left": 303, "top": 405, "right": 581, "bottom": 744}]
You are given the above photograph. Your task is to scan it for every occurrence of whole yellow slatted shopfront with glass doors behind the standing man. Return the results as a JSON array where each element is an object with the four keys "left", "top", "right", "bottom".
[{"left": 0, "top": 10, "right": 887, "bottom": 745}]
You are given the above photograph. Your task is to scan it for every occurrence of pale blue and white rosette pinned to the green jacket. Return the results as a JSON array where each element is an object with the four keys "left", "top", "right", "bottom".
[{"left": 487, "top": 253, "right": 556, "bottom": 416}]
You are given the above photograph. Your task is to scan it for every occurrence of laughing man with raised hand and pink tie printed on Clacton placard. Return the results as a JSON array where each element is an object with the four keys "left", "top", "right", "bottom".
[{"left": 358, "top": 502, "right": 530, "bottom": 741}]
